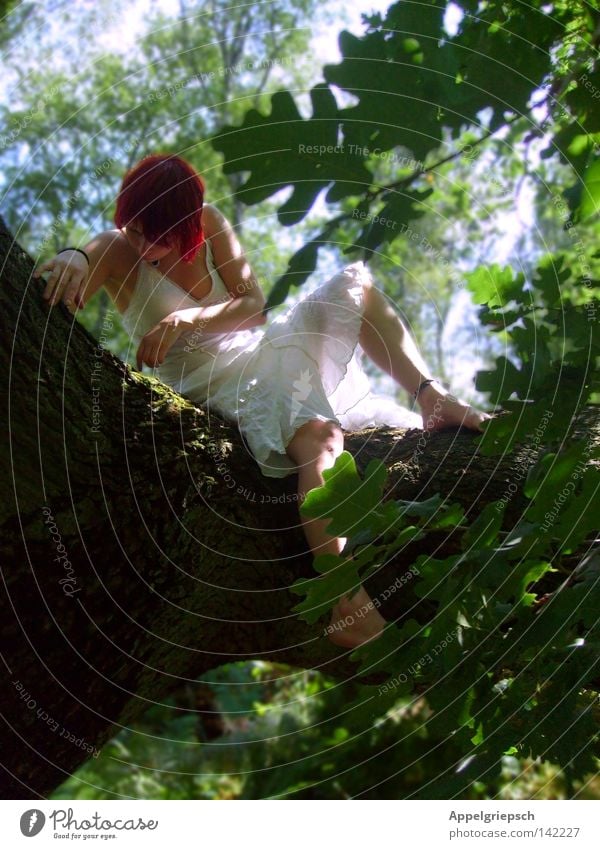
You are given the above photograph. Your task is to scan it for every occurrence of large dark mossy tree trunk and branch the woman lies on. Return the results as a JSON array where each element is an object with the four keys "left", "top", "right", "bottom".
[{"left": 0, "top": 221, "right": 596, "bottom": 798}]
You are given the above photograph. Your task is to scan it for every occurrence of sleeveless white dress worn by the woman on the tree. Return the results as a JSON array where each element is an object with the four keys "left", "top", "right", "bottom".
[{"left": 123, "top": 239, "right": 422, "bottom": 478}]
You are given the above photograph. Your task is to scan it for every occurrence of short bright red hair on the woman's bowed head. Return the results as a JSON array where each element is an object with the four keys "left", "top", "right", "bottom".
[{"left": 115, "top": 154, "right": 204, "bottom": 262}]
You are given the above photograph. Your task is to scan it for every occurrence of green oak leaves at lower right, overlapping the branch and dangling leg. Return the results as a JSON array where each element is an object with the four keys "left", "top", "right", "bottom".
[{"left": 294, "top": 245, "right": 600, "bottom": 798}]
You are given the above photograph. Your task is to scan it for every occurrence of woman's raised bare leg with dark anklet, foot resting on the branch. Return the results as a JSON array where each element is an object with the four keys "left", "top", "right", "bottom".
[{"left": 359, "top": 285, "right": 490, "bottom": 431}]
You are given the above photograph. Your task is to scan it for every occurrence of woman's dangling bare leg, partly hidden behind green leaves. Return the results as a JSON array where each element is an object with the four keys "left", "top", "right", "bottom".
[{"left": 287, "top": 419, "right": 385, "bottom": 648}]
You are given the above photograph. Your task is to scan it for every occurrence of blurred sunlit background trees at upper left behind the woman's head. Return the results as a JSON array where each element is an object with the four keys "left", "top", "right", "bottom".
[{"left": 0, "top": 0, "right": 328, "bottom": 363}]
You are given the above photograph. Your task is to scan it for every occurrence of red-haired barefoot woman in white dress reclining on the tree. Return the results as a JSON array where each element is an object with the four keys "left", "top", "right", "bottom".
[{"left": 35, "top": 155, "right": 486, "bottom": 647}]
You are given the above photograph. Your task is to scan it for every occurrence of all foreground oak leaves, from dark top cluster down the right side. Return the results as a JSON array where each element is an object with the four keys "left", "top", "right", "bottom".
[{"left": 213, "top": 0, "right": 600, "bottom": 798}]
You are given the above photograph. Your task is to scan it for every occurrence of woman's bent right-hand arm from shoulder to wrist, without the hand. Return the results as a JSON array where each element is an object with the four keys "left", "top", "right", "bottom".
[{"left": 177, "top": 204, "right": 266, "bottom": 333}]
